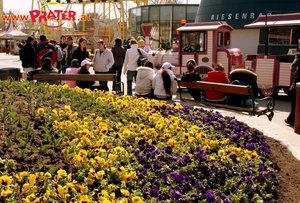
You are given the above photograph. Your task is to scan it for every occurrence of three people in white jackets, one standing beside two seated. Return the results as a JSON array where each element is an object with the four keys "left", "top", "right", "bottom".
[{"left": 122, "top": 39, "right": 177, "bottom": 100}]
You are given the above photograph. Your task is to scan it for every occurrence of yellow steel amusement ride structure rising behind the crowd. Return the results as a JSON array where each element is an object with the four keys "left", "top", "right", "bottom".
[{"left": 31, "top": 0, "right": 148, "bottom": 46}]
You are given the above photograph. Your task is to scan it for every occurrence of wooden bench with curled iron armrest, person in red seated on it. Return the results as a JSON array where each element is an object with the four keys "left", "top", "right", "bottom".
[{"left": 178, "top": 80, "right": 275, "bottom": 121}]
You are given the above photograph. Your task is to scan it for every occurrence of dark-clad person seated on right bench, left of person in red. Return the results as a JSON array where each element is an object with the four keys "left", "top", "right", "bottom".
[{"left": 181, "top": 59, "right": 202, "bottom": 101}]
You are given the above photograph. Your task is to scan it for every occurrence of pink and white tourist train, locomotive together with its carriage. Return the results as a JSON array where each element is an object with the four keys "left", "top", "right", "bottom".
[{"left": 150, "top": 13, "right": 300, "bottom": 96}]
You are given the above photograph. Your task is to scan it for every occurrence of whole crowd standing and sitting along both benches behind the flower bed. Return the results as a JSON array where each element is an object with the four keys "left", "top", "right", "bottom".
[{"left": 20, "top": 35, "right": 258, "bottom": 105}]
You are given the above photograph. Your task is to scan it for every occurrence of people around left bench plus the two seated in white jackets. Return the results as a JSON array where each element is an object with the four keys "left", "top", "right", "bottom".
[{"left": 20, "top": 35, "right": 177, "bottom": 99}]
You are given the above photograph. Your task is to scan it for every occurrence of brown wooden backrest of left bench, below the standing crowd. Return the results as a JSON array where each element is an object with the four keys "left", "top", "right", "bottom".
[{"left": 32, "top": 73, "right": 116, "bottom": 81}]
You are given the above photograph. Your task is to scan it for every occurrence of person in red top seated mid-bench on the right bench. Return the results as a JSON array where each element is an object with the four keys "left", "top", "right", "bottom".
[{"left": 205, "top": 63, "right": 229, "bottom": 102}]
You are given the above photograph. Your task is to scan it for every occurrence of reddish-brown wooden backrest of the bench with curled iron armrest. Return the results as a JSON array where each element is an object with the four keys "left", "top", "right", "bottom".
[{"left": 180, "top": 81, "right": 252, "bottom": 96}]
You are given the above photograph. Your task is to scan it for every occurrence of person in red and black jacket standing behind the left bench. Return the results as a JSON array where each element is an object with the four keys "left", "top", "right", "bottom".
[{"left": 34, "top": 35, "right": 57, "bottom": 67}]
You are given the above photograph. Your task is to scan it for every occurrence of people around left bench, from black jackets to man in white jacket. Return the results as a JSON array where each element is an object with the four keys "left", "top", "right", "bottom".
[{"left": 20, "top": 35, "right": 116, "bottom": 90}]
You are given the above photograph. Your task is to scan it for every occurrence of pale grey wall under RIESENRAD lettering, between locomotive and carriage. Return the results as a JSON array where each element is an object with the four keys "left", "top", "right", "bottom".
[{"left": 231, "top": 29, "right": 259, "bottom": 59}]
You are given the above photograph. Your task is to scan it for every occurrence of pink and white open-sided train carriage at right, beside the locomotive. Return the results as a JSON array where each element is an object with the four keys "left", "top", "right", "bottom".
[{"left": 244, "top": 13, "right": 300, "bottom": 96}]
